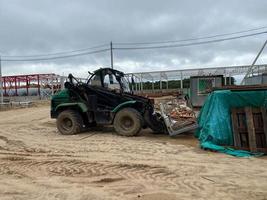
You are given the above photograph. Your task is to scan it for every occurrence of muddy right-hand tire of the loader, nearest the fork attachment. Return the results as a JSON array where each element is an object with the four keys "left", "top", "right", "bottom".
[{"left": 113, "top": 108, "right": 143, "bottom": 137}]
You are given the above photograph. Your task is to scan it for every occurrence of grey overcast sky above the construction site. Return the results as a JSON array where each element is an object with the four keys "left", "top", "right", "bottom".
[{"left": 0, "top": 0, "right": 267, "bottom": 77}]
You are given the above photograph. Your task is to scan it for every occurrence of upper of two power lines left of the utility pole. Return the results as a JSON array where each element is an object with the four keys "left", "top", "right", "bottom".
[{"left": 2, "top": 44, "right": 109, "bottom": 58}]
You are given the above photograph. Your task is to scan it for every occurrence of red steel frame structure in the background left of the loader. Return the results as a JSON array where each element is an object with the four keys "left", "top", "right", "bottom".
[{"left": 2, "top": 74, "right": 60, "bottom": 96}]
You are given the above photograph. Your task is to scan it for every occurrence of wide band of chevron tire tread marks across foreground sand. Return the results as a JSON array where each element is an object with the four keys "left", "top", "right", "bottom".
[{"left": 0, "top": 158, "right": 204, "bottom": 190}]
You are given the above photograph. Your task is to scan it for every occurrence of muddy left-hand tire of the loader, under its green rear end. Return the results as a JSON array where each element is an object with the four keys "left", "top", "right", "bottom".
[{"left": 57, "top": 110, "right": 83, "bottom": 135}]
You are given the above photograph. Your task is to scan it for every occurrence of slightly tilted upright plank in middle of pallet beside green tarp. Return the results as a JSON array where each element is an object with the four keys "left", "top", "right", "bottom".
[{"left": 245, "top": 107, "right": 257, "bottom": 152}]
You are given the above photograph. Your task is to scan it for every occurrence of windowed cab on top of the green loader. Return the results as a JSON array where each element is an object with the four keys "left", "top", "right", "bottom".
[{"left": 87, "top": 68, "right": 131, "bottom": 93}]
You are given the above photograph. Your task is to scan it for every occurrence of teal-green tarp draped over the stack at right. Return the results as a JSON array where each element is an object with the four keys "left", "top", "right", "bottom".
[{"left": 195, "top": 90, "right": 267, "bottom": 157}]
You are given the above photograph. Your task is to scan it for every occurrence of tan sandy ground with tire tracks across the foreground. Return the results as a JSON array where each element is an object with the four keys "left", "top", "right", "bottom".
[{"left": 0, "top": 105, "right": 267, "bottom": 200}]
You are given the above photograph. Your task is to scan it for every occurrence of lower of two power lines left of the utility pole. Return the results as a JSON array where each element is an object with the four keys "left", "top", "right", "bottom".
[{"left": 2, "top": 49, "right": 110, "bottom": 62}]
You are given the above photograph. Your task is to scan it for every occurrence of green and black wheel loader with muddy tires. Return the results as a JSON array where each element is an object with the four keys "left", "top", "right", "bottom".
[{"left": 51, "top": 68, "right": 167, "bottom": 136}]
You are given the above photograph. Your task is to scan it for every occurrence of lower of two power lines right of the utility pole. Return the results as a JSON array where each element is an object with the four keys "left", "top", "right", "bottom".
[{"left": 113, "top": 31, "right": 267, "bottom": 50}]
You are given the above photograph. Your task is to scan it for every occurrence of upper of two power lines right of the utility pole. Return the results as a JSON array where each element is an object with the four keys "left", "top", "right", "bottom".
[{"left": 113, "top": 26, "right": 267, "bottom": 45}]
